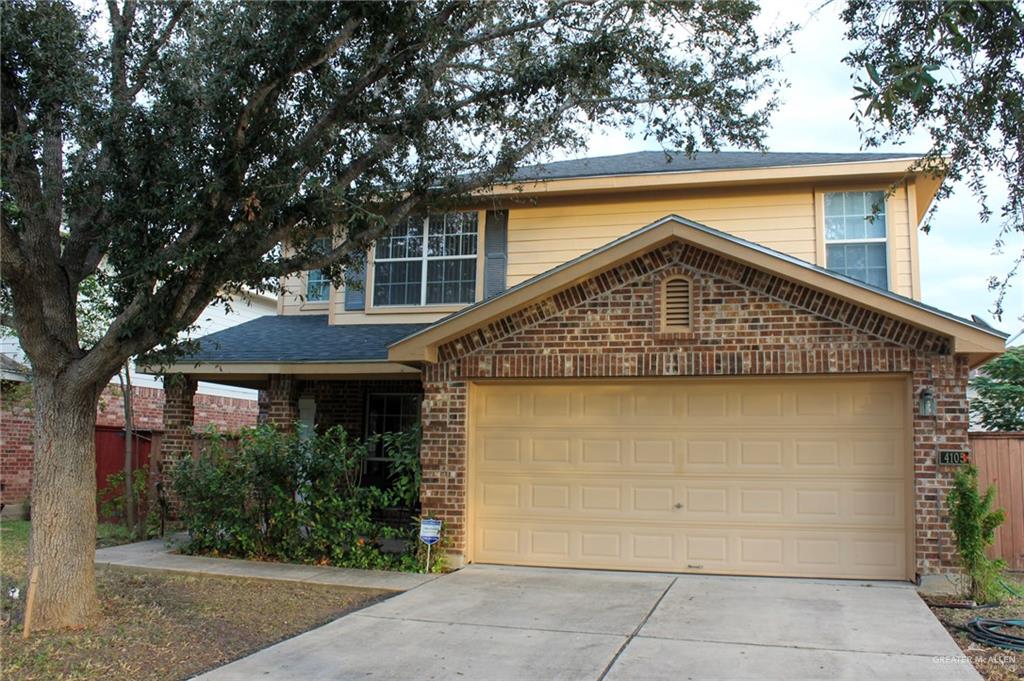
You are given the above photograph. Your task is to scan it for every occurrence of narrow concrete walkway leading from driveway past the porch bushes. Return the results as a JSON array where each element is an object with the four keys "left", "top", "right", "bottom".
[{"left": 96, "top": 538, "right": 438, "bottom": 591}]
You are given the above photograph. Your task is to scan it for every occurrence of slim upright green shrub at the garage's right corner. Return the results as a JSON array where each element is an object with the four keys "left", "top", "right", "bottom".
[{"left": 946, "top": 466, "right": 1006, "bottom": 603}]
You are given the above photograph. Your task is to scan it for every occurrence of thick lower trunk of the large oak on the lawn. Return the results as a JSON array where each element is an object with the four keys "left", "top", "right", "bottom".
[{"left": 29, "top": 373, "right": 99, "bottom": 630}]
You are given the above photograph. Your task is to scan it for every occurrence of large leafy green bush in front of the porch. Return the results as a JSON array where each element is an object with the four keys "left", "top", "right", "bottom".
[{"left": 173, "top": 426, "right": 421, "bottom": 569}]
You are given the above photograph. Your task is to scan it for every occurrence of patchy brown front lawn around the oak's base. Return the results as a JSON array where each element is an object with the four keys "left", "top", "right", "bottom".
[{"left": 0, "top": 521, "right": 387, "bottom": 679}]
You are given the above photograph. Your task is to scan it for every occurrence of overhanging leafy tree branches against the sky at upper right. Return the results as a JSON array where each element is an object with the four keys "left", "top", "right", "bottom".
[{"left": 843, "top": 0, "right": 1024, "bottom": 317}]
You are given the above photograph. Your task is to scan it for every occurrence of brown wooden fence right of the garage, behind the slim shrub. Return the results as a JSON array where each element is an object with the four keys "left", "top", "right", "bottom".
[{"left": 971, "top": 432, "right": 1024, "bottom": 570}]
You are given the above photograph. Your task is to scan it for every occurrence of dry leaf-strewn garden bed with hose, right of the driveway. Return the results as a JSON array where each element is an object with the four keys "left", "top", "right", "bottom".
[{"left": 928, "top": 577, "right": 1024, "bottom": 681}]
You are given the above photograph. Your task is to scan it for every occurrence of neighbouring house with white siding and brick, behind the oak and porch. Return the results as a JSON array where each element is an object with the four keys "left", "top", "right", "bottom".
[{"left": 0, "top": 294, "right": 278, "bottom": 513}]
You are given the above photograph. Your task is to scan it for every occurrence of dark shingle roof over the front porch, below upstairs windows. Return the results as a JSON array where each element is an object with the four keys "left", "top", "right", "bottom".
[{"left": 177, "top": 314, "right": 428, "bottom": 364}]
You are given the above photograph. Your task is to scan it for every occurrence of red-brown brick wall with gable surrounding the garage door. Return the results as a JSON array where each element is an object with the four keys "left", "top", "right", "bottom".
[{"left": 421, "top": 244, "right": 968, "bottom": 573}]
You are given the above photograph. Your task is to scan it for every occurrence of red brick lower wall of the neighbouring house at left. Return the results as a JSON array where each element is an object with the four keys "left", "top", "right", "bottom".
[{"left": 0, "top": 378, "right": 258, "bottom": 504}]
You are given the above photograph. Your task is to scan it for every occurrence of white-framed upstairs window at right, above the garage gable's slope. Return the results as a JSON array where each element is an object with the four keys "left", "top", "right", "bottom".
[{"left": 824, "top": 190, "right": 889, "bottom": 289}]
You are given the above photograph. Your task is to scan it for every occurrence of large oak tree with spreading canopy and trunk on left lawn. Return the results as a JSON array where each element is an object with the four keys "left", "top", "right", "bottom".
[{"left": 0, "top": 0, "right": 778, "bottom": 628}]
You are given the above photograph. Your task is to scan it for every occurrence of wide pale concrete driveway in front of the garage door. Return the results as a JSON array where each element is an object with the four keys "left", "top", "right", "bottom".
[{"left": 202, "top": 566, "right": 980, "bottom": 681}]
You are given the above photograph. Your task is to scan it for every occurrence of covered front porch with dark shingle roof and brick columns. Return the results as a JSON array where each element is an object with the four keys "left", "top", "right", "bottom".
[{"left": 145, "top": 314, "right": 424, "bottom": 503}]
